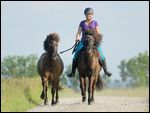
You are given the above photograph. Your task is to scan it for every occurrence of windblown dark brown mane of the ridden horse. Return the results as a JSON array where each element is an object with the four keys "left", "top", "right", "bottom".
[{"left": 84, "top": 29, "right": 102, "bottom": 45}]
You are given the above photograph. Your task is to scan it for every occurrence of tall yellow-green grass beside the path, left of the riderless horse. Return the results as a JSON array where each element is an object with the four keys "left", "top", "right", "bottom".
[{"left": 1, "top": 78, "right": 42, "bottom": 112}]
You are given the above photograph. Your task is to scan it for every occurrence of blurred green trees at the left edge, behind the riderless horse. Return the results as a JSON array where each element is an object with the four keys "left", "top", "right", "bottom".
[{"left": 1, "top": 55, "right": 37, "bottom": 77}]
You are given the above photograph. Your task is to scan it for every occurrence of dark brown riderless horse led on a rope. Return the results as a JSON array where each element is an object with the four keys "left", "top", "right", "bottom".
[{"left": 37, "top": 33, "right": 64, "bottom": 105}]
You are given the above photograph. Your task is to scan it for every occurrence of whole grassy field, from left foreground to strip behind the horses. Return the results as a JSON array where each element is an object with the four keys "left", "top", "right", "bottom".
[{"left": 1, "top": 77, "right": 149, "bottom": 112}]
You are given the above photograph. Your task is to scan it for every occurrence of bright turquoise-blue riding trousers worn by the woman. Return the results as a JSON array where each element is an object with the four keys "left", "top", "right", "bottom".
[{"left": 73, "top": 41, "right": 105, "bottom": 61}]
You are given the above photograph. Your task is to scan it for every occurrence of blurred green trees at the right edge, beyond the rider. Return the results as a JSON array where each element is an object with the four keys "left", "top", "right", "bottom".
[{"left": 118, "top": 52, "right": 149, "bottom": 86}]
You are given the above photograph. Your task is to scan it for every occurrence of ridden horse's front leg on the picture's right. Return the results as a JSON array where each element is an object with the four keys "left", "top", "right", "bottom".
[{"left": 88, "top": 76, "right": 94, "bottom": 105}]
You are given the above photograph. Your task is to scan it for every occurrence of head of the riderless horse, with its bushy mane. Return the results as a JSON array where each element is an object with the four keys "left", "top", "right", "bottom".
[{"left": 44, "top": 33, "right": 60, "bottom": 59}]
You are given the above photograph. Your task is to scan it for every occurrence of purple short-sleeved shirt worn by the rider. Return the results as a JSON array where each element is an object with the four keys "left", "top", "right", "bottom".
[{"left": 79, "top": 20, "right": 98, "bottom": 40}]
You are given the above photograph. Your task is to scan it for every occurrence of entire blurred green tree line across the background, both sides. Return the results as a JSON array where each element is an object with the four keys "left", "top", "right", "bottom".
[{"left": 1, "top": 51, "right": 149, "bottom": 89}]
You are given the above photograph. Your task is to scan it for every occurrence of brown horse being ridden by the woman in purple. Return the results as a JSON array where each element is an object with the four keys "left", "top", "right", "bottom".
[{"left": 77, "top": 30, "right": 103, "bottom": 105}]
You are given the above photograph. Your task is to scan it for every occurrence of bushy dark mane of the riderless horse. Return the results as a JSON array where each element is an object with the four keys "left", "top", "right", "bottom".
[{"left": 44, "top": 33, "right": 60, "bottom": 51}]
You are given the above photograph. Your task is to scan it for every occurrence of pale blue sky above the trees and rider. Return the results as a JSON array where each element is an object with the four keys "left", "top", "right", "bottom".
[{"left": 1, "top": 1, "right": 149, "bottom": 79}]
